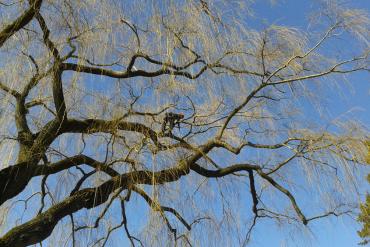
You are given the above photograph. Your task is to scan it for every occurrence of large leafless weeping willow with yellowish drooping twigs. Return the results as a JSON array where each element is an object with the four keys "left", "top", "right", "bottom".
[{"left": 0, "top": 0, "right": 370, "bottom": 246}]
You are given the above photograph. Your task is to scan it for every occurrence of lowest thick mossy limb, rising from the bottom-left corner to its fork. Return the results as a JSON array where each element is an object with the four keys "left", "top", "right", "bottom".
[{"left": 0, "top": 159, "right": 191, "bottom": 247}]
